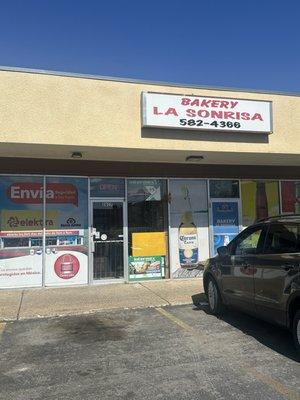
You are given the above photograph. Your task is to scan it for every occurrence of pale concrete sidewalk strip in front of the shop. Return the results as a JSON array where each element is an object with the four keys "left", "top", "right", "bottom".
[{"left": 0, "top": 278, "right": 203, "bottom": 321}]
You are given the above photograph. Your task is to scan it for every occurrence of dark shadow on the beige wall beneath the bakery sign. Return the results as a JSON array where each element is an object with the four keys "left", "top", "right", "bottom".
[{"left": 141, "top": 128, "right": 269, "bottom": 143}]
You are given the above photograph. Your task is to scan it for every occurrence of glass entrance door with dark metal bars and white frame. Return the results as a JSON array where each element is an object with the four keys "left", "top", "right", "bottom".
[{"left": 91, "top": 200, "right": 124, "bottom": 281}]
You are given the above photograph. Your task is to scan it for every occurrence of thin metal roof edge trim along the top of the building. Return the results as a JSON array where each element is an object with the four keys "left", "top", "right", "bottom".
[{"left": 0, "top": 65, "right": 300, "bottom": 97}]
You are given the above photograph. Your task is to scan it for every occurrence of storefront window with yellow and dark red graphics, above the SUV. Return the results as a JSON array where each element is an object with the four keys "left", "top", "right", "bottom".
[{"left": 241, "top": 180, "right": 279, "bottom": 226}]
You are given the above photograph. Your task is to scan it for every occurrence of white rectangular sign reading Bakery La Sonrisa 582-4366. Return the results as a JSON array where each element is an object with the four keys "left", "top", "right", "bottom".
[{"left": 142, "top": 92, "right": 272, "bottom": 133}]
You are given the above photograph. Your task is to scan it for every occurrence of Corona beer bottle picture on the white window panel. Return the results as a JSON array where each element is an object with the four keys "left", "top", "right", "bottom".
[{"left": 178, "top": 211, "right": 199, "bottom": 267}]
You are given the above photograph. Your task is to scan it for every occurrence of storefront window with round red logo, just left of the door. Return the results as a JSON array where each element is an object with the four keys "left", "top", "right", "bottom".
[{"left": 45, "top": 177, "right": 88, "bottom": 286}]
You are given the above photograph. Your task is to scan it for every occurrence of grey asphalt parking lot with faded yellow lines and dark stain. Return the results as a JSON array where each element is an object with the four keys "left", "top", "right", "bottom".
[{"left": 0, "top": 299, "right": 300, "bottom": 400}]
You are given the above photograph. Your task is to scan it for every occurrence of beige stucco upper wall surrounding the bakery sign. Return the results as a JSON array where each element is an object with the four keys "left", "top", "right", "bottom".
[{"left": 0, "top": 71, "right": 300, "bottom": 165}]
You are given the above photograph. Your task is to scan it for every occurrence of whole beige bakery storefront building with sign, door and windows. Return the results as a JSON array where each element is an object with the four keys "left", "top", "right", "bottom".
[{"left": 0, "top": 68, "right": 300, "bottom": 288}]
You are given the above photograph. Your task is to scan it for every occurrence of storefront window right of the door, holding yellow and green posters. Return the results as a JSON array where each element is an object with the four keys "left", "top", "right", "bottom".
[{"left": 127, "top": 179, "right": 168, "bottom": 280}]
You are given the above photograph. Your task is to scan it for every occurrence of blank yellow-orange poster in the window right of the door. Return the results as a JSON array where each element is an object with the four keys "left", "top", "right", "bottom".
[{"left": 132, "top": 232, "right": 167, "bottom": 257}]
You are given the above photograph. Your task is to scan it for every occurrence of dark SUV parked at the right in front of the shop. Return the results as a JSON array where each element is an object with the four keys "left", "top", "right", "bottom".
[{"left": 203, "top": 215, "right": 300, "bottom": 352}]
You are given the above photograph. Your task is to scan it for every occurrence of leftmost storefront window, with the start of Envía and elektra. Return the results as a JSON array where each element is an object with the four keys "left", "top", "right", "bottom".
[{"left": 0, "top": 176, "right": 43, "bottom": 288}]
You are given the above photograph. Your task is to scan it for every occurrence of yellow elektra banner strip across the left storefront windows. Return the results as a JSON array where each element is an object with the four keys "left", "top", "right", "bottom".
[{"left": 0, "top": 210, "right": 59, "bottom": 231}]
